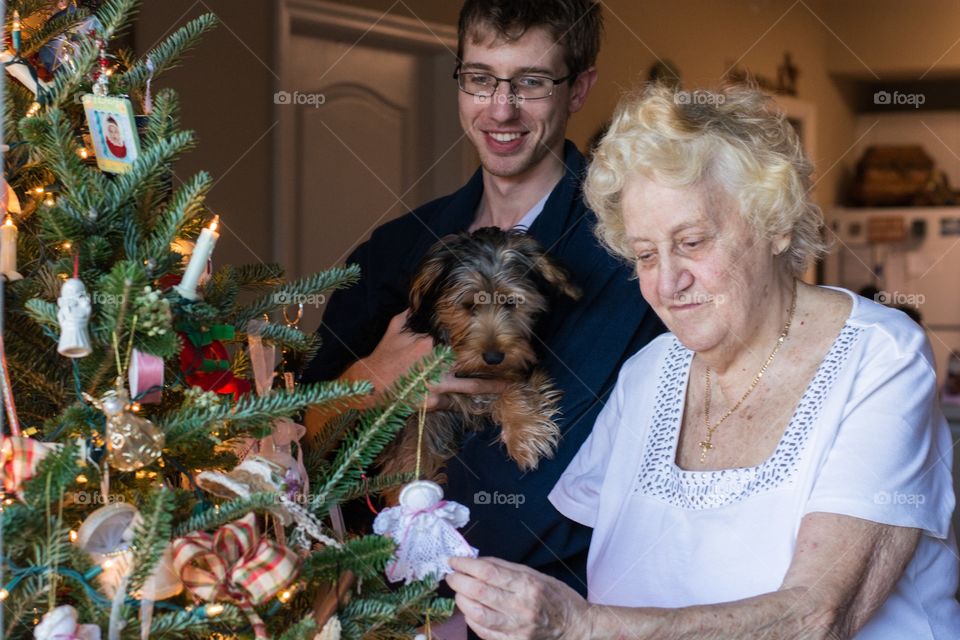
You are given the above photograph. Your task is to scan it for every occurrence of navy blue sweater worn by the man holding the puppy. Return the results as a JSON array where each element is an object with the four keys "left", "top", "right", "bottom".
[{"left": 304, "top": 141, "right": 664, "bottom": 594}]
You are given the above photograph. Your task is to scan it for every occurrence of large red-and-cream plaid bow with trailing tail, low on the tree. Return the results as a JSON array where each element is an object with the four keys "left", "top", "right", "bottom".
[{"left": 173, "top": 513, "right": 298, "bottom": 638}]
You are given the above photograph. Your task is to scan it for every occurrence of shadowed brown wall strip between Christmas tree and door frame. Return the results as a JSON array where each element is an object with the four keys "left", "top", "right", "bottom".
[{"left": 135, "top": 0, "right": 275, "bottom": 264}]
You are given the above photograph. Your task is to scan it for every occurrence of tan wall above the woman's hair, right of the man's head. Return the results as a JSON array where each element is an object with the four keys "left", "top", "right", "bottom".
[{"left": 571, "top": 0, "right": 853, "bottom": 210}]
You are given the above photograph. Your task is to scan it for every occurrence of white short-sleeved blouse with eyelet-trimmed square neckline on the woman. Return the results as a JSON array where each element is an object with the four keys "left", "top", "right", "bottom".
[{"left": 550, "top": 291, "right": 960, "bottom": 640}]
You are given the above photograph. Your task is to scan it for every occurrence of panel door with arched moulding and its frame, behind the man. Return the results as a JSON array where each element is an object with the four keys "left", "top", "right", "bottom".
[{"left": 273, "top": 0, "right": 476, "bottom": 310}]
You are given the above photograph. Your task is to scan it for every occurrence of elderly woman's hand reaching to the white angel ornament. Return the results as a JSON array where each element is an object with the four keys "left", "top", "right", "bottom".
[{"left": 447, "top": 558, "right": 591, "bottom": 640}]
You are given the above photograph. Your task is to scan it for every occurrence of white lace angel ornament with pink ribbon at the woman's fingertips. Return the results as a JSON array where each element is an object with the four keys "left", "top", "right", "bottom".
[{"left": 373, "top": 480, "right": 477, "bottom": 584}]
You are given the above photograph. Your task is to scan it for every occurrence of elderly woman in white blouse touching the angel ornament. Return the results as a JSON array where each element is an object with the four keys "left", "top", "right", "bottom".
[{"left": 448, "top": 86, "right": 960, "bottom": 640}]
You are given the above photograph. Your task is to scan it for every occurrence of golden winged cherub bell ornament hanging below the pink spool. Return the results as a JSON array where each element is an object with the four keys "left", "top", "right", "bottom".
[{"left": 84, "top": 378, "right": 164, "bottom": 471}]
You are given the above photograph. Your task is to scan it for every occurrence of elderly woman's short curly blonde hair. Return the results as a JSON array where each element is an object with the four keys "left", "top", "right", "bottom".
[{"left": 584, "top": 84, "right": 827, "bottom": 276}]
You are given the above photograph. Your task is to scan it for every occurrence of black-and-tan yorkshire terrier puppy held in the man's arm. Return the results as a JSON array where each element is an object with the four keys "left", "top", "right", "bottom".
[{"left": 383, "top": 227, "right": 580, "bottom": 481}]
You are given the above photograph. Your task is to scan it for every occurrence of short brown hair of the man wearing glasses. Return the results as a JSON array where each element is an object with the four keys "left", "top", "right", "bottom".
[{"left": 457, "top": 0, "right": 603, "bottom": 77}]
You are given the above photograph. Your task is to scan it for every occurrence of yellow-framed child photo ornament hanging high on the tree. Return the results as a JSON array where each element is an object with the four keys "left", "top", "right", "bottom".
[{"left": 83, "top": 95, "right": 140, "bottom": 173}]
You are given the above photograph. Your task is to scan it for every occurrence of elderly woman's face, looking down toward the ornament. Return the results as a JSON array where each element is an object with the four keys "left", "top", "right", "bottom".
[{"left": 622, "top": 175, "right": 786, "bottom": 353}]
